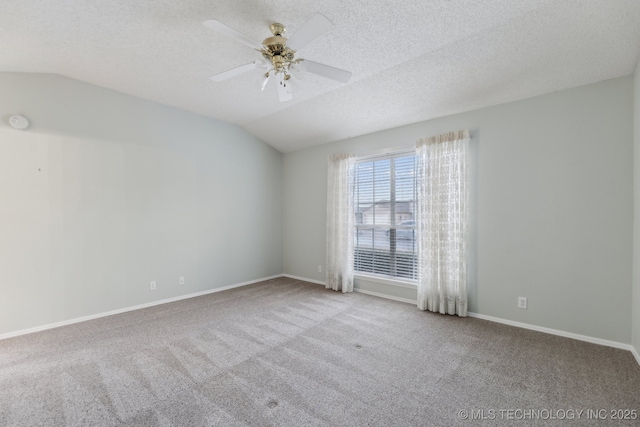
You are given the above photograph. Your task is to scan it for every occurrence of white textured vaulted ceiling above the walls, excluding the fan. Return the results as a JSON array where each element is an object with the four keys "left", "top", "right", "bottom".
[{"left": 0, "top": 0, "right": 640, "bottom": 152}]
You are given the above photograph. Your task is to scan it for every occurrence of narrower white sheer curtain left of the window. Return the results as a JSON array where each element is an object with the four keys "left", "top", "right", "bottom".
[{"left": 326, "top": 154, "right": 356, "bottom": 292}]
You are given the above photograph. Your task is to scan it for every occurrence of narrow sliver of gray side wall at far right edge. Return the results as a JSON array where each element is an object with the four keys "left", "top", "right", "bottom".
[{"left": 632, "top": 61, "right": 640, "bottom": 354}]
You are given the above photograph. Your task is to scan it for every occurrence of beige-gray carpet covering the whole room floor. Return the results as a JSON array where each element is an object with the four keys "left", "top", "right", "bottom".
[{"left": 0, "top": 278, "right": 640, "bottom": 426}]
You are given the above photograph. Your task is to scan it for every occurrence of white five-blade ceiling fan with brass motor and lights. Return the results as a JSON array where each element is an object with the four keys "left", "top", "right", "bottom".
[{"left": 203, "top": 14, "right": 351, "bottom": 102}]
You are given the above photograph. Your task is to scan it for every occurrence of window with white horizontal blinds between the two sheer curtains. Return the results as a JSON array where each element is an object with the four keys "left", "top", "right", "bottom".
[{"left": 354, "top": 150, "right": 417, "bottom": 280}]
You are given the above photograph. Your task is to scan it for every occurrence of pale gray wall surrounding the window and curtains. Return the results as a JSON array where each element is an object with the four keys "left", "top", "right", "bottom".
[{"left": 283, "top": 76, "right": 633, "bottom": 343}]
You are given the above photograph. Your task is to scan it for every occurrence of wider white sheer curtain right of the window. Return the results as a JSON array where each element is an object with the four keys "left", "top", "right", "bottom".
[{"left": 416, "top": 130, "right": 470, "bottom": 317}]
